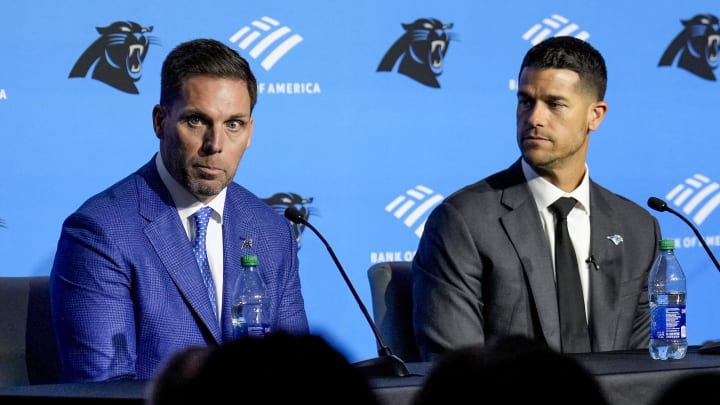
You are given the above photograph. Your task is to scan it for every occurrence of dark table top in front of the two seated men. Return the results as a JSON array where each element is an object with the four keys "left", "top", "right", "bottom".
[{"left": 0, "top": 346, "right": 720, "bottom": 405}]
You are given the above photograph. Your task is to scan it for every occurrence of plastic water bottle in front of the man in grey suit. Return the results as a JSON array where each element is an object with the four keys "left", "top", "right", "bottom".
[{"left": 648, "top": 239, "right": 687, "bottom": 360}]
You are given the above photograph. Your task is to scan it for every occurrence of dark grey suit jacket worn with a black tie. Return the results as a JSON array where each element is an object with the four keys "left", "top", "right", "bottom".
[{"left": 413, "top": 160, "right": 661, "bottom": 360}]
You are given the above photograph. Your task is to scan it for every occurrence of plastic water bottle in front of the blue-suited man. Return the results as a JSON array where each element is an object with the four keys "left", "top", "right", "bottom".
[{"left": 232, "top": 255, "right": 270, "bottom": 339}]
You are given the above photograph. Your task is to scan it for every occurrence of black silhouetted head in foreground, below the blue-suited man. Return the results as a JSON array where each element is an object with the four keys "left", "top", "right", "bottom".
[{"left": 151, "top": 333, "right": 378, "bottom": 405}]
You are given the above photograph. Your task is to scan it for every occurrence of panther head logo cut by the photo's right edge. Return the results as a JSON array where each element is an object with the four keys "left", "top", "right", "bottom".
[{"left": 658, "top": 14, "right": 720, "bottom": 81}]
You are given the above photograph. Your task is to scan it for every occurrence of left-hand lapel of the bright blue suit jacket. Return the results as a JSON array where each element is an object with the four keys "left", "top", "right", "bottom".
[{"left": 137, "top": 159, "right": 222, "bottom": 343}]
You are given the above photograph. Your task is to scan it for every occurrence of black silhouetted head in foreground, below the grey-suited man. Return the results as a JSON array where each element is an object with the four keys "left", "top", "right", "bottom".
[{"left": 413, "top": 336, "right": 608, "bottom": 405}]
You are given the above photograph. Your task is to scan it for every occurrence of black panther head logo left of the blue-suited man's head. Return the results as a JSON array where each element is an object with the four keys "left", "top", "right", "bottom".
[{"left": 68, "top": 21, "right": 156, "bottom": 94}]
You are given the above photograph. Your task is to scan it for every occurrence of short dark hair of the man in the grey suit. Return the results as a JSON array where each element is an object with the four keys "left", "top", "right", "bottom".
[{"left": 520, "top": 36, "right": 607, "bottom": 101}]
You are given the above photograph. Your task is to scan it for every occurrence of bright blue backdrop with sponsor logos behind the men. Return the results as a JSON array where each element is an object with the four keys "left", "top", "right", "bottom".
[{"left": 0, "top": 0, "right": 720, "bottom": 361}]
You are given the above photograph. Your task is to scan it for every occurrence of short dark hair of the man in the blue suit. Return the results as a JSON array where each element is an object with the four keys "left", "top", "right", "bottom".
[{"left": 160, "top": 38, "right": 257, "bottom": 113}]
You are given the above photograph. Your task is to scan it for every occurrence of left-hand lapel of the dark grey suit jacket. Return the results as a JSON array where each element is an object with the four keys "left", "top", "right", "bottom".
[{"left": 501, "top": 164, "right": 560, "bottom": 350}]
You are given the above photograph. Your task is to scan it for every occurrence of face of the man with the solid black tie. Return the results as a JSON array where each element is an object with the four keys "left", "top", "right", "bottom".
[{"left": 517, "top": 68, "right": 607, "bottom": 173}]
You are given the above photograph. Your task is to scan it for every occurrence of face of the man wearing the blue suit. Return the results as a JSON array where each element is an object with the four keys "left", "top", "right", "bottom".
[{"left": 153, "top": 76, "right": 253, "bottom": 203}]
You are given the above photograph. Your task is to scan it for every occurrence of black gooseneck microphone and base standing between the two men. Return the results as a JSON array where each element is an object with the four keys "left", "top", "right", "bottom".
[{"left": 285, "top": 205, "right": 410, "bottom": 377}]
